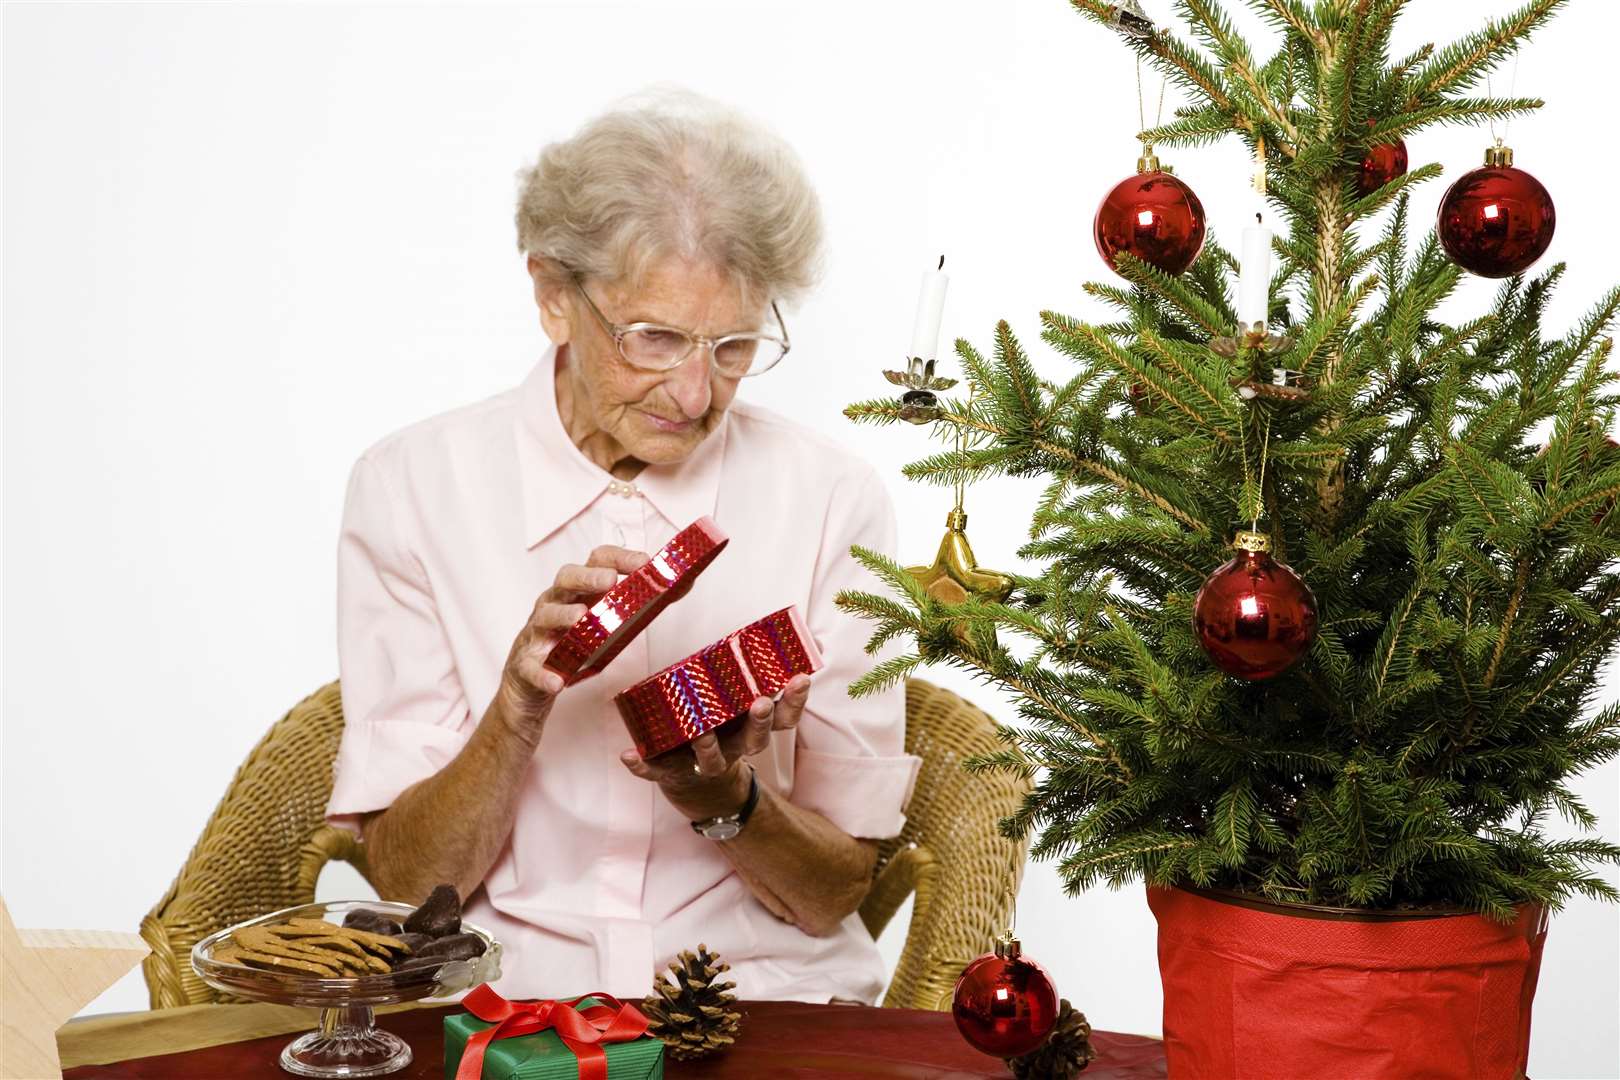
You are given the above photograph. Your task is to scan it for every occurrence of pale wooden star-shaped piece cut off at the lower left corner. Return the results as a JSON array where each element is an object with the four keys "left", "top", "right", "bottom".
[{"left": 0, "top": 899, "right": 149, "bottom": 1080}]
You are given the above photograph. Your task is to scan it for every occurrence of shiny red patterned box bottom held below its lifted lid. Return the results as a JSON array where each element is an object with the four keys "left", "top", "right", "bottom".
[{"left": 614, "top": 607, "right": 821, "bottom": 758}]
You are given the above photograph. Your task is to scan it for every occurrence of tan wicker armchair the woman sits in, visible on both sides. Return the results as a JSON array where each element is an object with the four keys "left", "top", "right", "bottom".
[{"left": 141, "top": 680, "right": 1025, "bottom": 1009}]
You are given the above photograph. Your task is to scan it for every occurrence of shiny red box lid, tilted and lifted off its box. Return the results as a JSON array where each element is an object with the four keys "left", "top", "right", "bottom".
[{"left": 546, "top": 517, "right": 731, "bottom": 685}]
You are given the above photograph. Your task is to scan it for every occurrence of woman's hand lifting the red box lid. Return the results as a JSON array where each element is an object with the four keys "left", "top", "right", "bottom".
[{"left": 496, "top": 544, "right": 648, "bottom": 738}]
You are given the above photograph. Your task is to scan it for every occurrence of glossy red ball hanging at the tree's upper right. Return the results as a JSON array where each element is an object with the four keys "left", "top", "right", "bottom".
[{"left": 1435, "top": 165, "right": 1555, "bottom": 277}]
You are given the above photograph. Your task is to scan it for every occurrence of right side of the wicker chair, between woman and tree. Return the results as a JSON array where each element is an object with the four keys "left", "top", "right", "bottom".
[{"left": 860, "top": 678, "right": 1029, "bottom": 1009}]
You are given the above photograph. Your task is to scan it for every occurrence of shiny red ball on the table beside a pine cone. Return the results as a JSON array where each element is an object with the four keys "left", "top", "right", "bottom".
[{"left": 951, "top": 939, "right": 1058, "bottom": 1057}]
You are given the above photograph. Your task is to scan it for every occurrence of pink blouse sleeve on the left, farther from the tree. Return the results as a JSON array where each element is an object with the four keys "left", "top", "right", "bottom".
[{"left": 326, "top": 457, "right": 471, "bottom": 832}]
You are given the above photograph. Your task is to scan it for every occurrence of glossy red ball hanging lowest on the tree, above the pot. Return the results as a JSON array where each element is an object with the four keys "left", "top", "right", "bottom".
[{"left": 1192, "top": 533, "right": 1317, "bottom": 682}]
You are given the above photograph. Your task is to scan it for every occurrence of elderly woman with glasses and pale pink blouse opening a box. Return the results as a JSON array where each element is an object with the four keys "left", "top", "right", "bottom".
[{"left": 327, "top": 96, "right": 919, "bottom": 1002}]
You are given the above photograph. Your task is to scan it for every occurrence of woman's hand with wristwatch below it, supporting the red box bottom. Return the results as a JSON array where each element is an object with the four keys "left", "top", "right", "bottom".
[{"left": 619, "top": 675, "right": 810, "bottom": 821}]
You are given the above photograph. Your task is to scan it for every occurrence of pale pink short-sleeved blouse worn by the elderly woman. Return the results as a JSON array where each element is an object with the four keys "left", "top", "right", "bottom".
[{"left": 327, "top": 348, "right": 920, "bottom": 1002}]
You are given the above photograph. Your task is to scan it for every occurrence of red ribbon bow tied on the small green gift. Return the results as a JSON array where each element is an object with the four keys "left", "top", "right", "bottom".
[{"left": 455, "top": 984, "right": 646, "bottom": 1080}]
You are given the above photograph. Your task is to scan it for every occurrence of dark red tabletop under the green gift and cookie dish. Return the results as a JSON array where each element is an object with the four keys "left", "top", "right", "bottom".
[{"left": 63, "top": 1001, "right": 1166, "bottom": 1080}]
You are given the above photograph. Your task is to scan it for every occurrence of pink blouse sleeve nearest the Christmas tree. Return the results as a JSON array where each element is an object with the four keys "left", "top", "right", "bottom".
[{"left": 791, "top": 468, "right": 922, "bottom": 839}]
